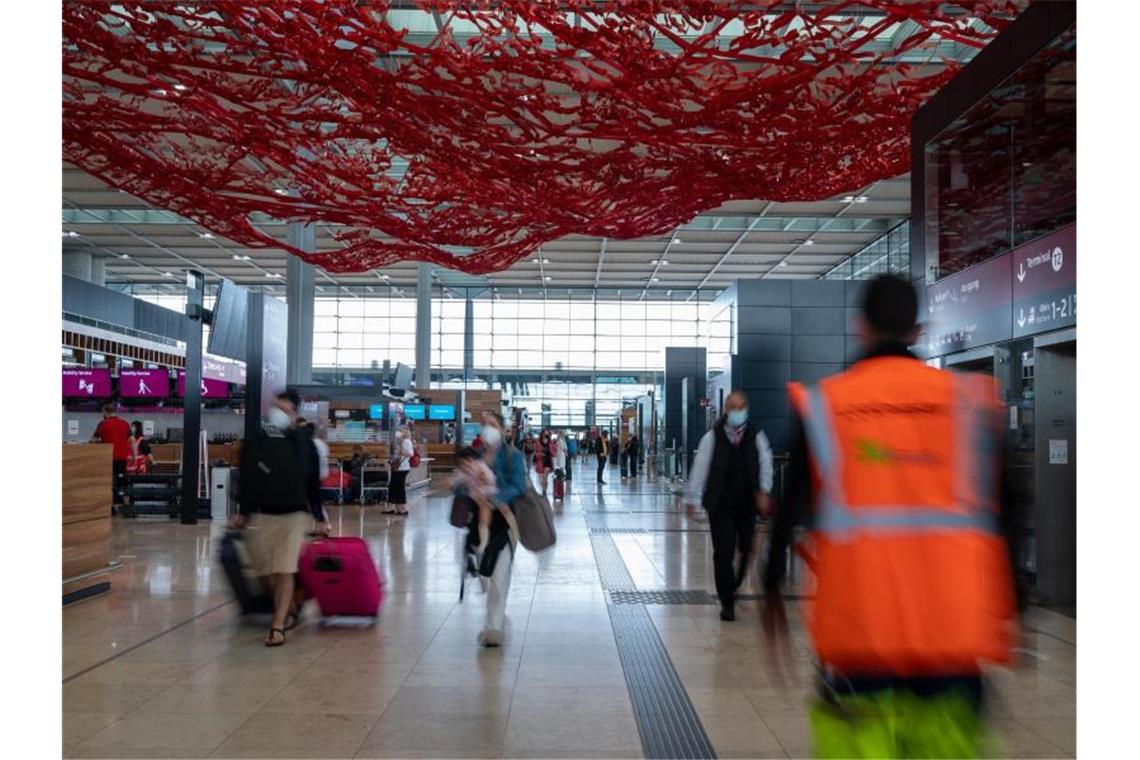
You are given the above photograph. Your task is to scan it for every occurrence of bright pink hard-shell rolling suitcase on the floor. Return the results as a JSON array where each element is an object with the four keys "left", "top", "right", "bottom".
[{"left": 300, "top": 537, "right": 383, "bottom": 618}]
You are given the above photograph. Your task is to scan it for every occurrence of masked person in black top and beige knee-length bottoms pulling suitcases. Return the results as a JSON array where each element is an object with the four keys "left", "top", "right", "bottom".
[{"left": 233, "top": 390, "right": 327, "bottom": 646}]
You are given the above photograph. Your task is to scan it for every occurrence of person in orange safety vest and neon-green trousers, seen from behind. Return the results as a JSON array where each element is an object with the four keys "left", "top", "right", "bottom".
[{"left": 762, "top": 275, "right": 1025, "bottom": 758}]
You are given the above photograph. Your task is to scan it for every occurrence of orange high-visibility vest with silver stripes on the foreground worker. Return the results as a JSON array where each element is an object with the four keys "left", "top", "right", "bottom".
[{"left": 790, "top": 357, "right": 1016, "bottom": 676}]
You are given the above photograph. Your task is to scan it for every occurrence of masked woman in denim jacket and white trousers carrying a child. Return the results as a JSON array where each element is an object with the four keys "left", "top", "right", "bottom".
[{"left": 479, "top": 411, "right": 528, "bottom": 647}]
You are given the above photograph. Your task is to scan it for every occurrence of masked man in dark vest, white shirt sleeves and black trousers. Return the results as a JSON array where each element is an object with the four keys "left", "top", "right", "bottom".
[{"left": 685, "top": 391, "right": 772, "bottom": 621}]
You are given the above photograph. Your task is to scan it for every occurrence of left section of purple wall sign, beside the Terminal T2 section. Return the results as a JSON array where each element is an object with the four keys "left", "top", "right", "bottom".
[{"left": 925, "top": 253, "right": 1013, "bottom": 357}]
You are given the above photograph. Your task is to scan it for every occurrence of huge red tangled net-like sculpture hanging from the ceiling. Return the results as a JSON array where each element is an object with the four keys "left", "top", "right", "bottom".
[{"left": 63, "top": 0, "right": 1024, "bottom": 273}]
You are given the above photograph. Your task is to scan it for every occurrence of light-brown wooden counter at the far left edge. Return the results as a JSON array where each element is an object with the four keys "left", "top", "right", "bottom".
[{"left": 63, "top": 443, "right": 112, "bottom": 604}]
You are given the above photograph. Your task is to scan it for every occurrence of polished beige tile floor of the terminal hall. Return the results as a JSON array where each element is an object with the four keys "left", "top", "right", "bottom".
[{"left": 63, "top": 465, "right": 1076, "bottom": 758}]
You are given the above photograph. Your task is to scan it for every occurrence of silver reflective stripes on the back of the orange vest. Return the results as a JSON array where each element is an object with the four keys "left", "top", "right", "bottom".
[{"left": 804, "top": 377, "right": 998, "bottom": 540}]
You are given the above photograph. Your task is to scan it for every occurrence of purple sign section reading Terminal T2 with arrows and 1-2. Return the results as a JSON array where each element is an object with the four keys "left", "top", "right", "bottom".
[{"left": 1011, "top": 223, "right": 1076, "bottom": 337}]
